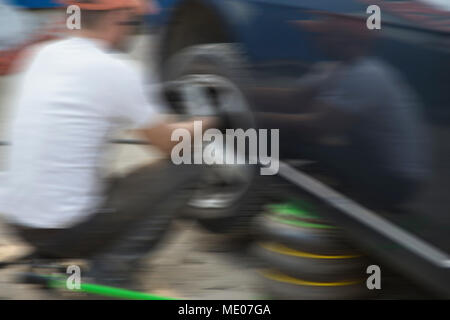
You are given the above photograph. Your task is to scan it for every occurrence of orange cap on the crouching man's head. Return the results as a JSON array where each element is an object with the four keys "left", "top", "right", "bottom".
[{"left": 60, "top": 0, "right": 158, "bottom": 14}]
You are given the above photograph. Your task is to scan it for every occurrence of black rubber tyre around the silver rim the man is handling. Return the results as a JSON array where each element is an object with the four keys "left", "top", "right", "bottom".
[{"left": 162, "top": 43, "right": 260, "bottom": 233}]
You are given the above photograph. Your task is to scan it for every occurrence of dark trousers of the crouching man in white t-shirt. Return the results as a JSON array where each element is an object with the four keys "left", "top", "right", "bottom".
[{"left": 11, "top": 161, "right": 201, "bottom": 268}]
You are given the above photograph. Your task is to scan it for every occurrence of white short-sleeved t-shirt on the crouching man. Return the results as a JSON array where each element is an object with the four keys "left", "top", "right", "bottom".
[{"left": 0, "top": 38, "right": 162, "bottom": 228}]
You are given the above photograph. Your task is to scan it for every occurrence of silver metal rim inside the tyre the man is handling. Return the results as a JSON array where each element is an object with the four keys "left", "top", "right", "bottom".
[{"left": 171, "top": 74, "right": 253, "bottom": 211}]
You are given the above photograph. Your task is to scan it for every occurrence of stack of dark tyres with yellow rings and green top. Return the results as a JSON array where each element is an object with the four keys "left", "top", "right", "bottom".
[{"left": 253, "top": 202, "right": 368, "bottom": 299}]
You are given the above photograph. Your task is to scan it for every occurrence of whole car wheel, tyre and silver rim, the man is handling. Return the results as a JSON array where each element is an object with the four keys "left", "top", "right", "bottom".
[{"left": 163, "top": 43, "right": 259, "bottom": 232}]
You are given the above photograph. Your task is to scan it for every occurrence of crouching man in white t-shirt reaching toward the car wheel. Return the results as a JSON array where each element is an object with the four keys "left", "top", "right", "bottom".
[{"left": 0, "top": 0, "right": 215, "bottom": 287}]
